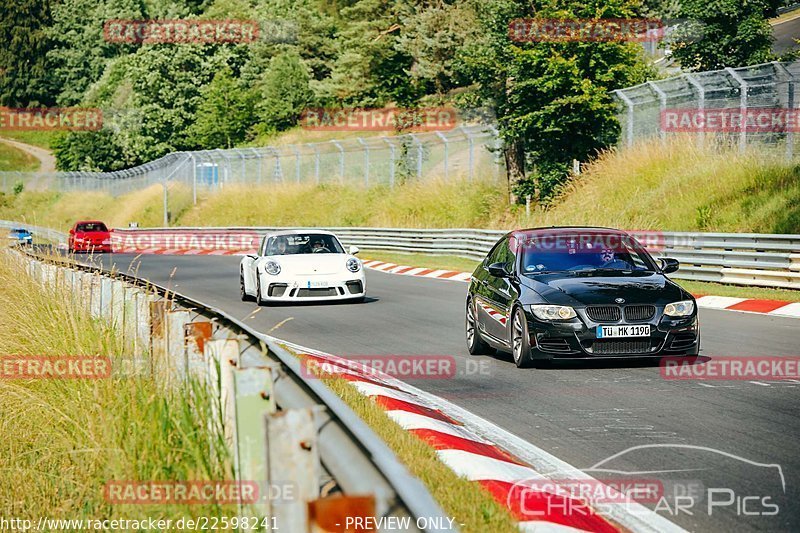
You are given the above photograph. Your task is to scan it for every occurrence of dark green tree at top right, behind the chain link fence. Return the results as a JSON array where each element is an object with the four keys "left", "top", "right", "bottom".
[{"left": 669, "top": 0, "right": 781, "bottom": 70}]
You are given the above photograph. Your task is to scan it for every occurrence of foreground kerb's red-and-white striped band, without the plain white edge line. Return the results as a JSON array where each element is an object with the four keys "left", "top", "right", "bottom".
[{"left": 280, "top": 341, "right": 682, "bottom": 533}]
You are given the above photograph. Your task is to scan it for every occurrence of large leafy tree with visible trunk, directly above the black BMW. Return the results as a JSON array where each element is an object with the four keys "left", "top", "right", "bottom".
[{"left": 462, "top": 0, "right": 651, "bottom": 203}]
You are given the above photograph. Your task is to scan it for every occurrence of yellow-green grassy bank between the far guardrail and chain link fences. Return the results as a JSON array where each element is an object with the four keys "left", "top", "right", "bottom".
[{"left": 0, "top": 139, "right": 800, "bottom": 233}]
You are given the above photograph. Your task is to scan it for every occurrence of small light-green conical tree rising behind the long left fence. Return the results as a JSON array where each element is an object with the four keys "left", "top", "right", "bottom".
[{"left": 191, "top": 66, "right": 254, "bottom": 149}]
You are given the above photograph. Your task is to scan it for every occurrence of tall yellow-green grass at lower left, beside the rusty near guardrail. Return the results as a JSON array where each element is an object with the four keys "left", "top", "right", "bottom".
[{"left": 0, "top": 253, "right": 236, "bottom": 523}]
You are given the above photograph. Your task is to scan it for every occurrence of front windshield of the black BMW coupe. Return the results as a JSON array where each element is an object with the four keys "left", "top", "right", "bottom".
[{"left": 521, "top": 234, "right": 656, "bottom": 274}]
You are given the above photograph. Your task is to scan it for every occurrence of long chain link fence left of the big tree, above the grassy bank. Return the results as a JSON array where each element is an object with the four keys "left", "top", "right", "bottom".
[{"left": 0, "top": 125, "right": 502, "bottom": 201}]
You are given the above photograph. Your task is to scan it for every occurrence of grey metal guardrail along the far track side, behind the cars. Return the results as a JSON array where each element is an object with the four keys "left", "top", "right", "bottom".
[{"left": 111, "top": 227, "right": 800, "bottom": 289}]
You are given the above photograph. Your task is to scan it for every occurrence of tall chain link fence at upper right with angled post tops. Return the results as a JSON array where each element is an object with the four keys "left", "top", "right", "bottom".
[{"left": 612, "top": 61, "right": 800, "bottom": 159}]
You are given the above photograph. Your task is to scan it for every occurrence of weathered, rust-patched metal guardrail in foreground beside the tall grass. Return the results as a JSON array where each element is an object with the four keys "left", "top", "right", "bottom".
[{"left": 15, "top": 246, "right": 453, "bottom": 532}]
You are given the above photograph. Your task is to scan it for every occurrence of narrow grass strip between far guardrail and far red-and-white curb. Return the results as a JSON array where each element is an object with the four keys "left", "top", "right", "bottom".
[{"left": 359, "top": 250, "right": 800, "bottom": 302}]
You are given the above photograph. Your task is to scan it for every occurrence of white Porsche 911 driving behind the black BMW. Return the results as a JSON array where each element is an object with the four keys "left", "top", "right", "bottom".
[{"left": 239, "top": 230, "right": 367, "bottom": 305}]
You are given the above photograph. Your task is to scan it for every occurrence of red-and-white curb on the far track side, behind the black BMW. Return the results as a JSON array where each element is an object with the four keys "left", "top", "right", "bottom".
[{"left": 364, "top": 260, "right": 800, "bottom": 318}]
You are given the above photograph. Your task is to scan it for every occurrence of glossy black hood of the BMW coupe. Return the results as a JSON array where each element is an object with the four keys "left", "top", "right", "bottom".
[{"left": 523, "top": 272, "right": 686, "bottom": 305}]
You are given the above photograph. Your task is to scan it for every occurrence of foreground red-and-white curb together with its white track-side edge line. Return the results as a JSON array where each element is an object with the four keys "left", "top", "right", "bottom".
[{"left": 274, "top": 339, "right": 684, "bottom": 533}]
